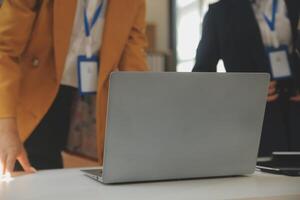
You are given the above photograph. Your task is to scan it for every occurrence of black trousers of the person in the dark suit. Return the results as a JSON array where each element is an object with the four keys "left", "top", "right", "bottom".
[{"left": 259, "top": 89, "right": 300, "bottom": 157}]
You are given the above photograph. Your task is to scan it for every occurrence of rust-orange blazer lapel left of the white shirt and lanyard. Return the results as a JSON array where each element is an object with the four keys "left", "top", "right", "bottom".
[{"left": 53, "top": 0, "right": 77, "bottom": 80}]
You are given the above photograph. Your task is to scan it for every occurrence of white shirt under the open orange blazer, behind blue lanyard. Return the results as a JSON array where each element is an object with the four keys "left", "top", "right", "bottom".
[{"left": 61, "top": 0, "right": 107, "bottom": 88}]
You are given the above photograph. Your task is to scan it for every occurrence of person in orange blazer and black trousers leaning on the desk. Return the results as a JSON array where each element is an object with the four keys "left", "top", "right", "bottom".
[{"left": 0, "top": 0, "right": 147, "bottom": 175}]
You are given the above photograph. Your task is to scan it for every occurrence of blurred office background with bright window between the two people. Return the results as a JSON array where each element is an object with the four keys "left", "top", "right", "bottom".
[{"left": 147, "top": 0, "right": 225, "bottom": 72}]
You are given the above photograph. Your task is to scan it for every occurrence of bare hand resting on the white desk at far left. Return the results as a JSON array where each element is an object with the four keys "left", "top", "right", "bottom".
[{"left": 0, "top": 118, "right": 35, "bottom": 175}]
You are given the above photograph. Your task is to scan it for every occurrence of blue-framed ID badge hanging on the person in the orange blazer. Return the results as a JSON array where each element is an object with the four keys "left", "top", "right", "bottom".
[{"left": 77, "top": 55, "right": 99, "bottom": 96}]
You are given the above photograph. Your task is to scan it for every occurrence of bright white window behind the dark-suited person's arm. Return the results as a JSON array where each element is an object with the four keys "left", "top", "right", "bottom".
[{"left": 176, "top": 0, "right": 225, "bottom": 72}]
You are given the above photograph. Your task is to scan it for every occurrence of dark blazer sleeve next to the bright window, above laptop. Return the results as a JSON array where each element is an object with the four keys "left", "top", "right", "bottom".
[{"left": 193, "top": 8, "right": 220, "bottom": 72}]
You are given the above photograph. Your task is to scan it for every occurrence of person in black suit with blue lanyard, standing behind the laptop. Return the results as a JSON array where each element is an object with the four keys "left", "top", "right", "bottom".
[{"left": 193, "top": 0, "right": 300, "bottom": 157}]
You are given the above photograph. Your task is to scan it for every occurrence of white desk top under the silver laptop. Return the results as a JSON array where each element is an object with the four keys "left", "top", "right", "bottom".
[{"left": 0, "top": 169, "right": 300, "bottom": 200}]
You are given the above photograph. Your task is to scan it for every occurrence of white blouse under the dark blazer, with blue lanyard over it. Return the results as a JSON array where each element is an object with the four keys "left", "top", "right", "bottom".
[{"left": 252, "top": 0, "right": 292, "bottom": 51}]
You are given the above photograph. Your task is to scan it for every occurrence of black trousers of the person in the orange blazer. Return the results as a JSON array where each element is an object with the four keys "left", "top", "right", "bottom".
[{"left": 16, "top": 86, "right": 76, "bottom": 170}]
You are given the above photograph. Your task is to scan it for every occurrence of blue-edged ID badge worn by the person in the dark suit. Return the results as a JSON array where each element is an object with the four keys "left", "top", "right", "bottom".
[{"left": 267, "top": 46, "right": 292, "bottom": 80}]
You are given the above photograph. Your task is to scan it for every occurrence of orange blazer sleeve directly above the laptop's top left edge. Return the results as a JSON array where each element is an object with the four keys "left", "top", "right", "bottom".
[{"left": 119, "top": 0, "right": 148, "bottom": 71}]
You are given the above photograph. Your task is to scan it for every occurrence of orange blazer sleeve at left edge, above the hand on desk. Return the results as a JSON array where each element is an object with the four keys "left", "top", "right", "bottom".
[{"left": 0, "top": 0, "right": 37, "bottom": 118}]
